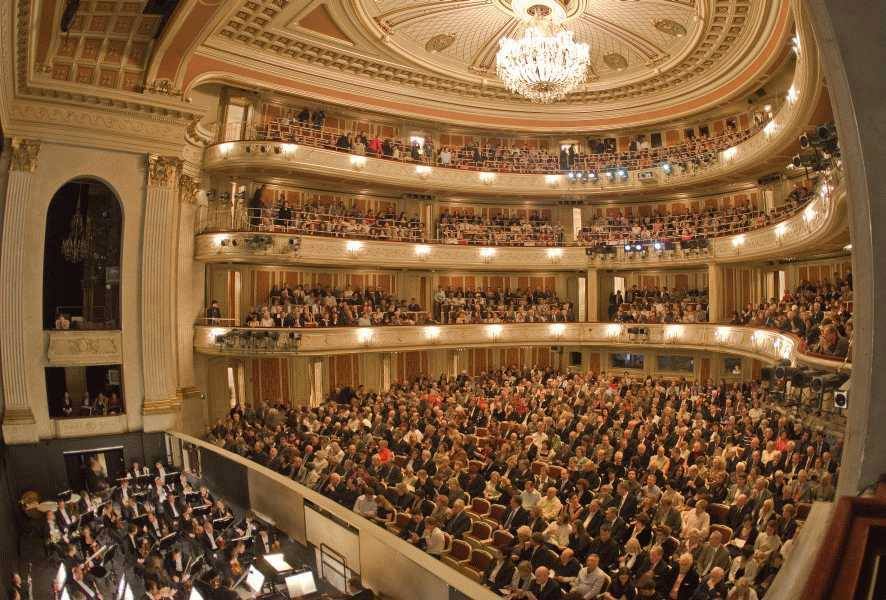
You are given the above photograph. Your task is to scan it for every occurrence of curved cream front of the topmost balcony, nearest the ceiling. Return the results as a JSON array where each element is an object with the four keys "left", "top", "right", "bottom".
[{"left": 204, "top": 31, "right": 821, "bottom": 197}]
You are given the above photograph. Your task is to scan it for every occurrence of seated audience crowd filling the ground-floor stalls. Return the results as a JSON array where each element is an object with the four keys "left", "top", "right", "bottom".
[{"left": 209, "top": 368, "right": 841, "bottom": 598}]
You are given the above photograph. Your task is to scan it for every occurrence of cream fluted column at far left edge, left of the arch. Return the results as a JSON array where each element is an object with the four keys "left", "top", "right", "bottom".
[{"left": 0, "top": 139, "right": 42, "bottom": 444}]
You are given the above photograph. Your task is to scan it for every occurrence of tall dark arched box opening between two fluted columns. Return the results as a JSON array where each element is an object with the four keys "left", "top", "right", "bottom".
[{"left": 43, "top": 179, "right": 123, "bottom": 329}]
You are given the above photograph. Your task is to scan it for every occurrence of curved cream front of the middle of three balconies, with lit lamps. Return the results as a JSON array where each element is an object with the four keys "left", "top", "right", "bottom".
[{"left": 195, "top": 171, "right": 848, "bottom": 271}]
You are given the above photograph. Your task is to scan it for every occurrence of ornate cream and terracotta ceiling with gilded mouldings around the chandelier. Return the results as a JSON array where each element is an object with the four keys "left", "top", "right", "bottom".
[{"left": 6, "top": 0, "right": 792, "bottom": 131}]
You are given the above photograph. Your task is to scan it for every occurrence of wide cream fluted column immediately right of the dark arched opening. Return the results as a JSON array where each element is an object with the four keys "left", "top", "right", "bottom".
[{"left": 141, "top": 155, "right": 184, "bottom": 431}]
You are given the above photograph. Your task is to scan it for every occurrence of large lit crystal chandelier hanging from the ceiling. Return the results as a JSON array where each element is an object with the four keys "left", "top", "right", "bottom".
[{"left": 495, "top": 0, "right": 590, "bottom": 103}]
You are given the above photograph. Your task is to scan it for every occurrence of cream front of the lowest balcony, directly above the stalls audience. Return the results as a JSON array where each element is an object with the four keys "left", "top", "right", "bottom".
[{"left": 194, "top": 322, "right": 852, "bottom": 371}]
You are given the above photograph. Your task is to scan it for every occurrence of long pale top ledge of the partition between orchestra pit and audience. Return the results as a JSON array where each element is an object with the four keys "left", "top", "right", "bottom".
[{"left": 166, "top": 431, "right": 501, "bottom": 600}]
